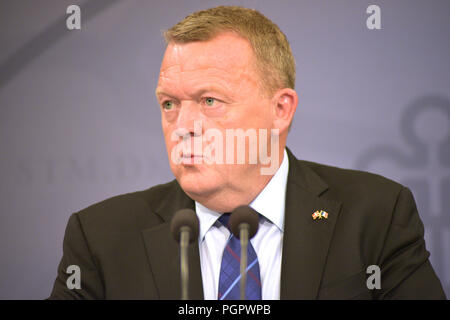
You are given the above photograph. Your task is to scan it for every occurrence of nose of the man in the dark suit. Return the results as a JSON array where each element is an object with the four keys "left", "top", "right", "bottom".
[{"left": 175, "top": 101, "right": 203, "bottom": 138}]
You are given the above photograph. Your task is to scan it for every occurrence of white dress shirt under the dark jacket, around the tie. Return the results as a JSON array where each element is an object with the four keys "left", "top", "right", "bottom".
[{"left": 195, "top": 150, "right": 289, "bottom": 300}]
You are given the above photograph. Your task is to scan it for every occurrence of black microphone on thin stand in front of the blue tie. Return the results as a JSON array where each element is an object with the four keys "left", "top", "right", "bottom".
[{"left": 229, "top": 206, "right": 259, "bottom": 300}]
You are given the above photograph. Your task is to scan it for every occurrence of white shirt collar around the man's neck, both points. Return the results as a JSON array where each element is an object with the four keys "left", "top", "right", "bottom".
[{"left": 195, "top": 149, "right": 289, "bottom": 241}]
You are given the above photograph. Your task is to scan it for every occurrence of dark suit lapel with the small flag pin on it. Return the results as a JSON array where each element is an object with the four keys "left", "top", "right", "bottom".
[{"left": 280, "top": 150, "right": 341, "bottom": 299}]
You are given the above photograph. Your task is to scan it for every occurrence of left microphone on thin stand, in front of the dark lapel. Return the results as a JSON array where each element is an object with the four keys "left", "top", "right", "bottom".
[{"left": 170, "top": 209, "right": 199, "bottom": 300}]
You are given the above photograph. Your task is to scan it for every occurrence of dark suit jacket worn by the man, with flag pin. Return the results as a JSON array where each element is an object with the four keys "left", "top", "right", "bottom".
[{"left": 50, "top": 151, "right": 445, "bottom": 299}]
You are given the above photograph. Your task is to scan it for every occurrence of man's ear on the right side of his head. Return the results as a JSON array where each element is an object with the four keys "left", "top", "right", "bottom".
[{"left": 272, "top": 88, "right": 298, "bottom": 135}]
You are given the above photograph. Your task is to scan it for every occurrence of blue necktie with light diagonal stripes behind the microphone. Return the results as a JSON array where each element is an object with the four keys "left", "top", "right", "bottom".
[{"left": 218, "top": 213, "right": 261, "bottom": 300}]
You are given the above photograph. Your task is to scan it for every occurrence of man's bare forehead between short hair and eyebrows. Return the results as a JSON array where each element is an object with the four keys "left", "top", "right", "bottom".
[{"left": 159, "top": 33, "right": 255, "bottom": 84}]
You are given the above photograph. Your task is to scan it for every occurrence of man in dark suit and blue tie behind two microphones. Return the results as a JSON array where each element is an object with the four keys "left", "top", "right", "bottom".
[{"left": 50, "top": 7, "right": 445, "bottom": 299}]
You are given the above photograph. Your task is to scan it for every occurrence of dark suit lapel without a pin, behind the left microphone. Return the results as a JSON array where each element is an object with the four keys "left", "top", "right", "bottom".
[{"left": 142, "top": 181, "right": 203, "bottom": 300}]
